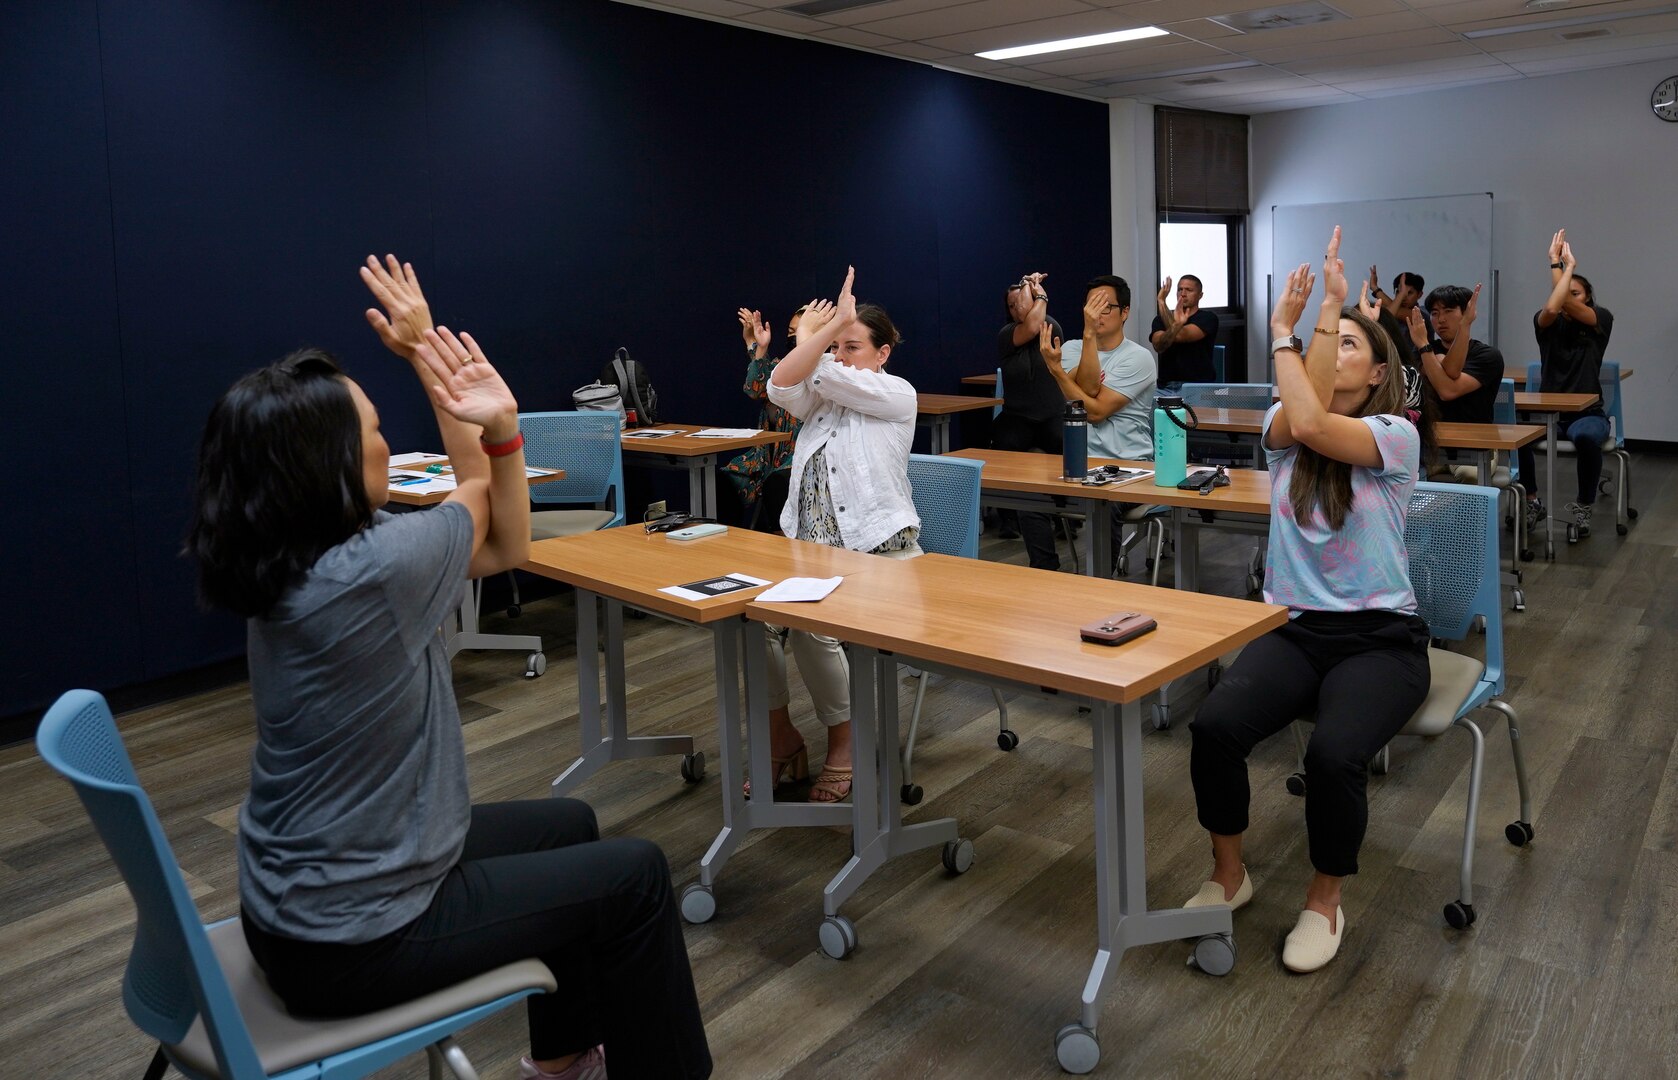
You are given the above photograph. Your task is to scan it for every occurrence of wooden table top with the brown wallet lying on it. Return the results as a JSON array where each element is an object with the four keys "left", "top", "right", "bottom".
[{"left": 747, "top": 555, "right": 1287, "bottom": 704}]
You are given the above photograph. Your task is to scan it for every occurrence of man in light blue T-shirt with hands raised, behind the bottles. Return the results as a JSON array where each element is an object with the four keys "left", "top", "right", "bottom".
[{"left": 1039, "top": 273, "right": 1158, "bottom": 461}]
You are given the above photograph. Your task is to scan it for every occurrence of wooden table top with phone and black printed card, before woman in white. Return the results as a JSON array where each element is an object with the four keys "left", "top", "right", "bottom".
[{"left": 522, "top": 525, "right": 893, "bottom": 622}]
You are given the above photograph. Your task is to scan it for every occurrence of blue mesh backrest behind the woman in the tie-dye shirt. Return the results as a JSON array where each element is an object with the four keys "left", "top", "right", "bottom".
[{"left": 1404, "top": 483, "right": 1503, "bottom": 693}]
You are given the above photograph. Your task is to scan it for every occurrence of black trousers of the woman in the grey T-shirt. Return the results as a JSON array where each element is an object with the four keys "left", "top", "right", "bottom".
[{"left": 243, "top": 798, "right": 711, "bottom": 1080}]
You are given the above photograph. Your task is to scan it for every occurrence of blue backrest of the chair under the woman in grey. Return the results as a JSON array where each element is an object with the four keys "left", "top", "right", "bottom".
[{"left": 35, "top": 689, "right": 267, "bottom": 1080}]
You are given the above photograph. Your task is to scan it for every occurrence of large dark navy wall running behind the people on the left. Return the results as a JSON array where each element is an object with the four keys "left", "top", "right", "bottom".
[{"left": 0, "top": 0, "right": 1109, "bottom": 714}]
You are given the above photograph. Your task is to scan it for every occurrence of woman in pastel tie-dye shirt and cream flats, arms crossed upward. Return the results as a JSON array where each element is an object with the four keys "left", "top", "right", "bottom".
[{"left": 1186, "top": 228, "right": 1428, "bottom": 971}]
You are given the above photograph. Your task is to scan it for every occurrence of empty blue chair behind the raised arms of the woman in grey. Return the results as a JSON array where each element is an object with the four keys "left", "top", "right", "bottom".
[{"left": 507, "top": 413, "right": 624, "bottom": 619}]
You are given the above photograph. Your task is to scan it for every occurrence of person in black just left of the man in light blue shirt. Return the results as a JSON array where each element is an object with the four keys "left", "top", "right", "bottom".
[{"left": 990, "top": 272, "right": 1064, "bottom": 570}]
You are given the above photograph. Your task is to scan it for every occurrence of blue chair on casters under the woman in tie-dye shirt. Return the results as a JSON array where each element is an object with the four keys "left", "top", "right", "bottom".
[{"left": 1287, "top": 483, "right": 1534, "bottom": 929}]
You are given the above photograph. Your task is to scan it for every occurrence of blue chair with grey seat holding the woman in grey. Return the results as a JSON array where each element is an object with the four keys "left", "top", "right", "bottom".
[{"left": 35, "top": 689, "right": 555, "bottom": 1080}]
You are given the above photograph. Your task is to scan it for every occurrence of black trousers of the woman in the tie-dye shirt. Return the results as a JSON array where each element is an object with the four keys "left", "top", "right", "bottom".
[{"left": 1188, "top": 610, "right": 1428, "bottom": 877}]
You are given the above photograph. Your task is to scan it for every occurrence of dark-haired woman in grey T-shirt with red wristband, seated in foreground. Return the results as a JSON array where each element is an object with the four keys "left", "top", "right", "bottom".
[{"left": 186, "top": 257, "right": 710, "bottom": 1080}]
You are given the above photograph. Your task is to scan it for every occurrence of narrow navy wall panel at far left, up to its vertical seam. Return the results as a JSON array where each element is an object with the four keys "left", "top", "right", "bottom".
[{"left": 0, "top": 0, "right": 144, "bottom": 713}]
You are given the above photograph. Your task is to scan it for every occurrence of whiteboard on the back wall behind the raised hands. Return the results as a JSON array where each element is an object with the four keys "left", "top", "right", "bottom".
[{"left": 1265, "top": 191, "right": 1497, "bottom": 344}]
